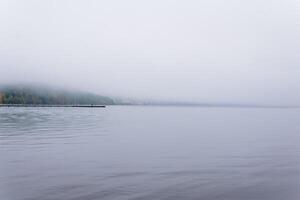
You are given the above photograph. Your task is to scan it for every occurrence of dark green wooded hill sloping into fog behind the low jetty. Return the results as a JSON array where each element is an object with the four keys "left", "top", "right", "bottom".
[{"left": 0, "top": 86, "right": 116, "bottom": 105}]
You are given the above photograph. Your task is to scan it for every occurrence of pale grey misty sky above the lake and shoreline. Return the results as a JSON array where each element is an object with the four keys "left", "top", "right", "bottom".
[{"left": 0, "top": 0, "right": 300, "bottom": 105}]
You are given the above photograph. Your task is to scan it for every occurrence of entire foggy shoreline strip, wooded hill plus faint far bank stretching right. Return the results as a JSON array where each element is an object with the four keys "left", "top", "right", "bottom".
[{"left": 0, "top": 85, "right": 290, "bottom": 108}]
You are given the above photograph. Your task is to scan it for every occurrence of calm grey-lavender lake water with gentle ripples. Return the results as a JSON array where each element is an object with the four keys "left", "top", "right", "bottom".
[{"left": 0, "top": 106, "right": 300, "bottom": 200}]
